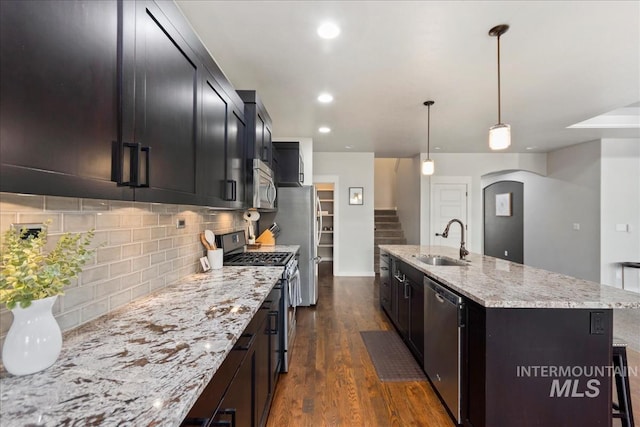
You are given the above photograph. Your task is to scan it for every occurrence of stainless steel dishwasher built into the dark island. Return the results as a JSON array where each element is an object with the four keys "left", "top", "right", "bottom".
[{"left": 424, "top": 276, "right": 464, "bottom": 424}]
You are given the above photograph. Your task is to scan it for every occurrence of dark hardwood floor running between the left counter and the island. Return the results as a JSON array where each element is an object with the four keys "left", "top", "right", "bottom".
[{"left": 267, "top": 265, "right": 453, "bottom": 427}]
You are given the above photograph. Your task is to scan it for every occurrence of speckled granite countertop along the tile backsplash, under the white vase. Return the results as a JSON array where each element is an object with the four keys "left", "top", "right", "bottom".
[{"left": 0, "top": 267, "right": 283, "bottom": 427}]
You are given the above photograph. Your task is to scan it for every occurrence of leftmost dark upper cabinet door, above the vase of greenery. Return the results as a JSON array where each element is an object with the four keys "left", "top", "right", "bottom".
[{"left": 0, "top": 0, "right": 133, "bottom": 199}]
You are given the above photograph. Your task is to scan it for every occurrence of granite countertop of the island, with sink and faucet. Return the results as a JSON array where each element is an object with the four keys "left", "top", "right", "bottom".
[{"left": 380, "top": 245, "right": 640, "bottom": 308}]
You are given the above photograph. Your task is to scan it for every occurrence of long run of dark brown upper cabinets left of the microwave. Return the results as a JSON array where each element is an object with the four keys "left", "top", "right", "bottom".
[{"left": 0, "top": 0, "right": 252, "bottom": 209}]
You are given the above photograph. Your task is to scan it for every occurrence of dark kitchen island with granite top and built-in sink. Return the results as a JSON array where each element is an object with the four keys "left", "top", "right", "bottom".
[{"left": 380, "top": 245, "right": 640, "bottom": 427}]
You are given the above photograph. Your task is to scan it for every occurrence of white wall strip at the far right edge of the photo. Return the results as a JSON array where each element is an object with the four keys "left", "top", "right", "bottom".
[{"left": 600, "top": 139, "right": 640, "bottom": 292}]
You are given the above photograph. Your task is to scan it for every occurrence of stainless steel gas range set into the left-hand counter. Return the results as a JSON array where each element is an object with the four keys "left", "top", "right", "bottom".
[{"left": 218, "top": 231, "right": 300, "bottom": 372}]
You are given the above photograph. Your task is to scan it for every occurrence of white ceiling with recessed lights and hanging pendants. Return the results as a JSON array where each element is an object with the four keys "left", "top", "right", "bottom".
[{"left": 176, "top": 0, "right": 640, "bottom": 157}]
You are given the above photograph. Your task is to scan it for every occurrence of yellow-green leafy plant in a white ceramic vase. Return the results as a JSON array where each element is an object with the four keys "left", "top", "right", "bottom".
[{"left": 0, "top": 222, "right": 95, "bottom": 375}]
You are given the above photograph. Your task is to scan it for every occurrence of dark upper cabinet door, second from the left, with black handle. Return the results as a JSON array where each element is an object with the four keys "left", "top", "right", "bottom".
[{"left": 124, "top": 1, "right": 201, "bottom": 204}]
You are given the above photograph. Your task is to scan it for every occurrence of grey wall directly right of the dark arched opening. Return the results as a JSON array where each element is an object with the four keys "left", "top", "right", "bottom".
[{"left": 482, "top": 141, "right": 600, "bottom": 282}]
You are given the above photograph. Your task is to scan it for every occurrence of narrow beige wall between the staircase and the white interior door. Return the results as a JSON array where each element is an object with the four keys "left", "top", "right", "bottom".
[{"left": 394, "top": 156, "right": 422, "bottom": 245}]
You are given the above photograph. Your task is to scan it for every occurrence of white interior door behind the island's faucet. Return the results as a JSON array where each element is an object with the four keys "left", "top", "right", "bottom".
[{"left": 430, "top": 182, "right": 469, "bottom": 248}]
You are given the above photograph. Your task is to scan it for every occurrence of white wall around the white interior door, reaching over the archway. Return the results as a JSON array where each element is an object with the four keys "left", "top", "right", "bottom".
[{"left": 416, "top": 153, "right": 547, "bottom": 253}]
